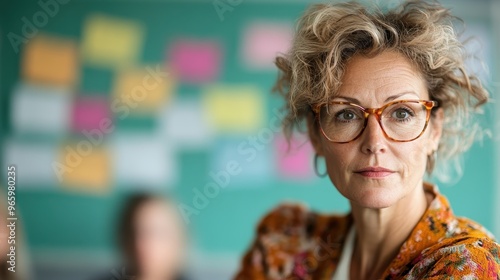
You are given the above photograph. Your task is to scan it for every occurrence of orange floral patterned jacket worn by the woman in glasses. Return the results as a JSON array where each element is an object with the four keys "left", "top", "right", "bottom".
[{"left": 234, "top": 183, "right": 500, "bottom": 280}]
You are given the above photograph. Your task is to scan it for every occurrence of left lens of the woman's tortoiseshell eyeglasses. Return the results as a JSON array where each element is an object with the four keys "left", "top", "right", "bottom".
[{"left": 320, "top": 104, "right": 365, "bottom": 142}]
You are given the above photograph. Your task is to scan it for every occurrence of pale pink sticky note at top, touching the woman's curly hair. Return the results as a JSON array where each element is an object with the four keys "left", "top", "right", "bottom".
[{"left": 241, "top": 22, "right": 293, "bottom": 70}]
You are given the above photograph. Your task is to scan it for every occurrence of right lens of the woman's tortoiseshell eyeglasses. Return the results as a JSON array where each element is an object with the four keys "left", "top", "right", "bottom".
[{"left": 380, "top": 102, "right": 427, "bottom": 141}]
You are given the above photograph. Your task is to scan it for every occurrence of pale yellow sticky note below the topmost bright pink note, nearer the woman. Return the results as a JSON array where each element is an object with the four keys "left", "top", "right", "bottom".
[{"left": 204, "top": 85, "right": 265, "bottom": 133}]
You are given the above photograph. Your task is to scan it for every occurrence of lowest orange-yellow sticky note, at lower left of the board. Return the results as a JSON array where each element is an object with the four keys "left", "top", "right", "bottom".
[{"left": 55, "top": 145, "right": 111, "bottom": 193}]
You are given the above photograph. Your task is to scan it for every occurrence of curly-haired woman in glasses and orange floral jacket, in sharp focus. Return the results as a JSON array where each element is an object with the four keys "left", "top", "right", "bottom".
[{"left": 236, "top": 1, "right": 500, "bottom": 279}]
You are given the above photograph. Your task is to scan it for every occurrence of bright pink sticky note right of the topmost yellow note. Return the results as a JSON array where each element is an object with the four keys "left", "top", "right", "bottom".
[{"left": 169, "top": 40, "right": 222, "bottom": 84}]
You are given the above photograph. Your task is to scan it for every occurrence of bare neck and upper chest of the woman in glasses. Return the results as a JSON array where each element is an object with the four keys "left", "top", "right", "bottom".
[{"left": 350, "top": 184, "right": 432, "bottom": 279}]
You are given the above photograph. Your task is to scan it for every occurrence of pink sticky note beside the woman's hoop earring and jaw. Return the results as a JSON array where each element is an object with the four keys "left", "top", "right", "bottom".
[{"left": 275, "top": 136, "right": 313, "bottom": 179}]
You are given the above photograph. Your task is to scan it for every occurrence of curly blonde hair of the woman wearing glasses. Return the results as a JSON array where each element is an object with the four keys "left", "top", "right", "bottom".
[{"left": 275, "top": 0, "right": 488, "bottom": 179}]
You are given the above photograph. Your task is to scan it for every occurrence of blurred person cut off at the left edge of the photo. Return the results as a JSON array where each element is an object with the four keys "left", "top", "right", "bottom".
[{"left": 0, "top": 189, "right": 32, "bottom": 280}]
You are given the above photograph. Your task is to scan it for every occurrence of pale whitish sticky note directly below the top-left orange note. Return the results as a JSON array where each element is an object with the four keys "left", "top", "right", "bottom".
[{"left": 11, "top": 83, "right": 72, "bottom": 134}]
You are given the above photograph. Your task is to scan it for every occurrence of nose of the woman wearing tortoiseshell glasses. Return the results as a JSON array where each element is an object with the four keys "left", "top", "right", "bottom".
[{"left": 361, "top": 115, "right": 387, "bottom": 154}]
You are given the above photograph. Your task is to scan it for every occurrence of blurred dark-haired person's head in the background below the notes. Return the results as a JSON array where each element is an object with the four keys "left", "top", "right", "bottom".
[{"left": 118, "top": 194, "right": 187, "bottom": 280}]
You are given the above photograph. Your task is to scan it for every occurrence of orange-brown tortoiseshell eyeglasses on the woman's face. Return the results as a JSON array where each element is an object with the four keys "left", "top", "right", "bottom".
[{"left": 312, "top": 100, "right": 438, "bottom": 143}]
